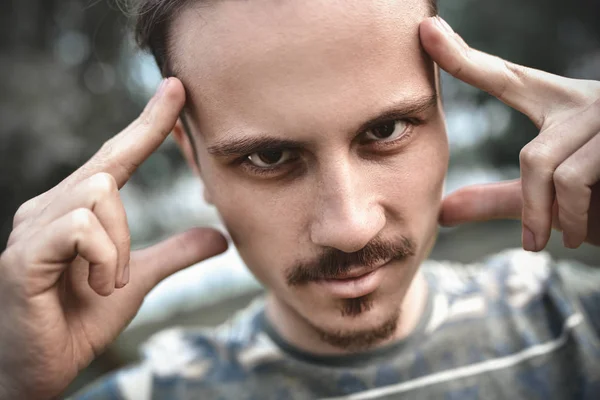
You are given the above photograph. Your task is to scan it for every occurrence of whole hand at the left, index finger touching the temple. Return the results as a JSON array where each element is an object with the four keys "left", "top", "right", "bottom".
[{"left": 0, "top": 78, "right": 227, "bottom": 399}]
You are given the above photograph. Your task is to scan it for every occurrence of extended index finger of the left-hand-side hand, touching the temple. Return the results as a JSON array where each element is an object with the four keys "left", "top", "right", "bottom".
[{"left": 74, "top": 78, "right": 185, "bottom": 188}]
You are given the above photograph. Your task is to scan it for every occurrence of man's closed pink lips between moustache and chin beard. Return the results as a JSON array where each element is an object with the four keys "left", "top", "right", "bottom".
[{"left": 315, "top": 260, "right": 390, "bottom": 299}]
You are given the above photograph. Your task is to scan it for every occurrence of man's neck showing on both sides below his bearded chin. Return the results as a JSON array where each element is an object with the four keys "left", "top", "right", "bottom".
[{"left": 266, "top": 270, "right": 428, "bottom": 355}]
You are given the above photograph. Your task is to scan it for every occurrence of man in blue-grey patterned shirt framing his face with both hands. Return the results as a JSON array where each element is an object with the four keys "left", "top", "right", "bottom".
[{"left": 0, "top": 0, "right": 600, "bottom": 399}]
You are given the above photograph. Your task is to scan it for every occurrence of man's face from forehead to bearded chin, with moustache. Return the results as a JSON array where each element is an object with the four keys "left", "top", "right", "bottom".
[{"left": 173, "top": 0, "right": 448, "bottom": 348}]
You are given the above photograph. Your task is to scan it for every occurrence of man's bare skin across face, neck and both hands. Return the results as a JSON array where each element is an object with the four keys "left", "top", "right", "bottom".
[{"left": 0, "top": 0, "right": 600, "bottom": 399}]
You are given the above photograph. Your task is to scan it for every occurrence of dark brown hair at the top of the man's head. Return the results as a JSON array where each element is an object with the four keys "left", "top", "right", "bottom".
[{"left": 134, "top": 0, "right": 437, "bottom": 76}]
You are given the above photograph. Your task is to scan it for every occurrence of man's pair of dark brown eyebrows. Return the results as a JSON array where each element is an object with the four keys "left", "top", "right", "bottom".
[{"left": 207, "top": 93, "right": 438, "bottom": 157}]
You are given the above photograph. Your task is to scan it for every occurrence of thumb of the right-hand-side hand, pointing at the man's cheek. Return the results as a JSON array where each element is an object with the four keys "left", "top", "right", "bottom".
[{"left": 439, "top": 179, "right": 523, "bottom": 226}]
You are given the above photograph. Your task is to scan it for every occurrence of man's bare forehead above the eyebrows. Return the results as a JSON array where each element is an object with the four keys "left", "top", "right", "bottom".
[{"left": 172, "top": 0, "right": 433, "bottom": 135}]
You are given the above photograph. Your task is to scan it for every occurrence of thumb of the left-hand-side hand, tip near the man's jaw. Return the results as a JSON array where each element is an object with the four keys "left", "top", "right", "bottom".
[{"left": 130, "top": 228, "right": 227, "bottom": 293}]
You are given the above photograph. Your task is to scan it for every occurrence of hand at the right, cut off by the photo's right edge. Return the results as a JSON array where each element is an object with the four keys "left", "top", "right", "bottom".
[{"left": 420, "top": 17, "right": 600, "bottom": 251}]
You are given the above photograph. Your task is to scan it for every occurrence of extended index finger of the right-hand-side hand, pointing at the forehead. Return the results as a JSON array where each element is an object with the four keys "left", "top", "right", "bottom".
[{"left": 419, "top": 17, "right": 564, "bottom": 128}]
